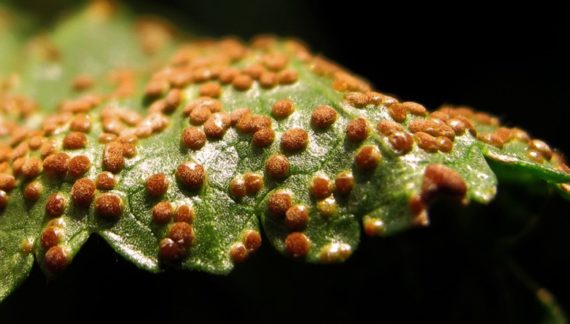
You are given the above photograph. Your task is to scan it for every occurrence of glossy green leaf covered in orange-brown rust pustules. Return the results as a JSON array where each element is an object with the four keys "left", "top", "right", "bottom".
[{"left": 0, "top": 1, "right": 570, "bottom": 299}]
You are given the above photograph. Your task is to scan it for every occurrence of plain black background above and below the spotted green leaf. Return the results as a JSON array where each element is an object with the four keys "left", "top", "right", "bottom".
[{"left": 0, "top": 0, "right": 570, "bottom": 323}]
